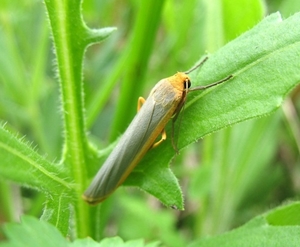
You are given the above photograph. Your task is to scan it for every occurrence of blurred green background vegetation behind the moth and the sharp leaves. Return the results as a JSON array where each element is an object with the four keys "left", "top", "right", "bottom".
[{"left": 0, "top": 0, "right": 300, "bottom": 246}]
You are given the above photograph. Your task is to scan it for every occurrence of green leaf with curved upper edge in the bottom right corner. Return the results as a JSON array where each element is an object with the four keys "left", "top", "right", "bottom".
[{"left": 189, "top": 203, "right": 300, "bottom": 247}]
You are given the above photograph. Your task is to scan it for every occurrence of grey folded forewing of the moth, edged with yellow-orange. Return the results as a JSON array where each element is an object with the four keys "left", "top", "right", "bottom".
[{"left": 85, "top": 85, "right": 178, "bottom": 199}]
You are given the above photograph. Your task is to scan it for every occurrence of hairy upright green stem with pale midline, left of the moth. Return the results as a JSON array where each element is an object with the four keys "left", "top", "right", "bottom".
[{"left": 45, "top": 0, "right": 91, "bottom": 237}]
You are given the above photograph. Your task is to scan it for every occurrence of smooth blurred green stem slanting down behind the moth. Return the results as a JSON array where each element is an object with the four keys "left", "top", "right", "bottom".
[{"left": 111, "top": 0, "right": 164, "bottom": 140}]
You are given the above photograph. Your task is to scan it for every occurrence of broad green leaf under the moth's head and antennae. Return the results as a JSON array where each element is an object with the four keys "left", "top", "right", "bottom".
[{"left": 125, "top": 13, "right": 300, "bottom": 208}]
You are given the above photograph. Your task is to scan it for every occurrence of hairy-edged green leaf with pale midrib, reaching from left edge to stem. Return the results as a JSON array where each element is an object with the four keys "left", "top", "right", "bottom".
[{"left": 0, "top": 126, "right": 71, "bottom": 195}]
